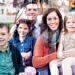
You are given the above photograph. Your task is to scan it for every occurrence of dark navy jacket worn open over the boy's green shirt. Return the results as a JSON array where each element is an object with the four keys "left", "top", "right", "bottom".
[{"left": 9, "top": 43, "right": 24, "bottom": 75}]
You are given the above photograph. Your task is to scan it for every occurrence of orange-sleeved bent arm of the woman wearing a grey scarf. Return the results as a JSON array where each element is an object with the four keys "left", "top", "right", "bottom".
[{"left": 32, "top": 37, "right": 57, "bottom": 68}]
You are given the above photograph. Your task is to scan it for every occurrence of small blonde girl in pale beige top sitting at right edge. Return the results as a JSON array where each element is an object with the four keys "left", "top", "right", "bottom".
[{"left": 50, "top": 12, "right": 75, "bottom": 75}]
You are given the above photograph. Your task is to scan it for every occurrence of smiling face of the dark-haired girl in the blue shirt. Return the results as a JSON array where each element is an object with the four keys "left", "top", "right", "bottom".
[{"left": 17, "top": 24, "right": 29, "bottom": 37}]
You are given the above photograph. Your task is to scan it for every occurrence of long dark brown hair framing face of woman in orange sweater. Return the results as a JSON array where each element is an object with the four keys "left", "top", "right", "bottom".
[{"left": 42, "top": 8, "right": 63, "bottom": 31}]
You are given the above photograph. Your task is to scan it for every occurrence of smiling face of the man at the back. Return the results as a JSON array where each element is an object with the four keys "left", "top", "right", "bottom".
[{"left": 26, "top": 4, "right": 38, "bottom": 20}]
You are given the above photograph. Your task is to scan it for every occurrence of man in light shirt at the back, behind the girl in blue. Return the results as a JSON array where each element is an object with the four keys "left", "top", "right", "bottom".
[{"left": 10, "top": 1, "right": 41, "bottom": 38}]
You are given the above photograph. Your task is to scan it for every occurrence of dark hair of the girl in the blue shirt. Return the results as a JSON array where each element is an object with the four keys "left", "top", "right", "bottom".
[{"left": 13, "top": 19, "right": 31, "bottom": 38}]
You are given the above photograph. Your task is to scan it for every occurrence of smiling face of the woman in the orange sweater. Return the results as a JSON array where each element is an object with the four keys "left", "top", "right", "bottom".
[{"left": 47, "top": 11, "right": 59, "bottom": 31}]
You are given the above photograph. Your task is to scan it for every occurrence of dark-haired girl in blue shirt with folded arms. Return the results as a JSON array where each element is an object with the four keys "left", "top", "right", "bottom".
[{"left": 10, "top": 19, "right": 35, "bottom": 66}]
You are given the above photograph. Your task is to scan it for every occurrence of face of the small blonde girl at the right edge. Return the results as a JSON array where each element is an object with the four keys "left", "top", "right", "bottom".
[{"left": 66, "top": 16, "right": 75, "bottom": 32}]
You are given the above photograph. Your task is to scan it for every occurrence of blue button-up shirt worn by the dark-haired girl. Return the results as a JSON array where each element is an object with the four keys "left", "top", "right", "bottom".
[{"left": 9, "top": 36, "right": 36, "bottom": 66}]
